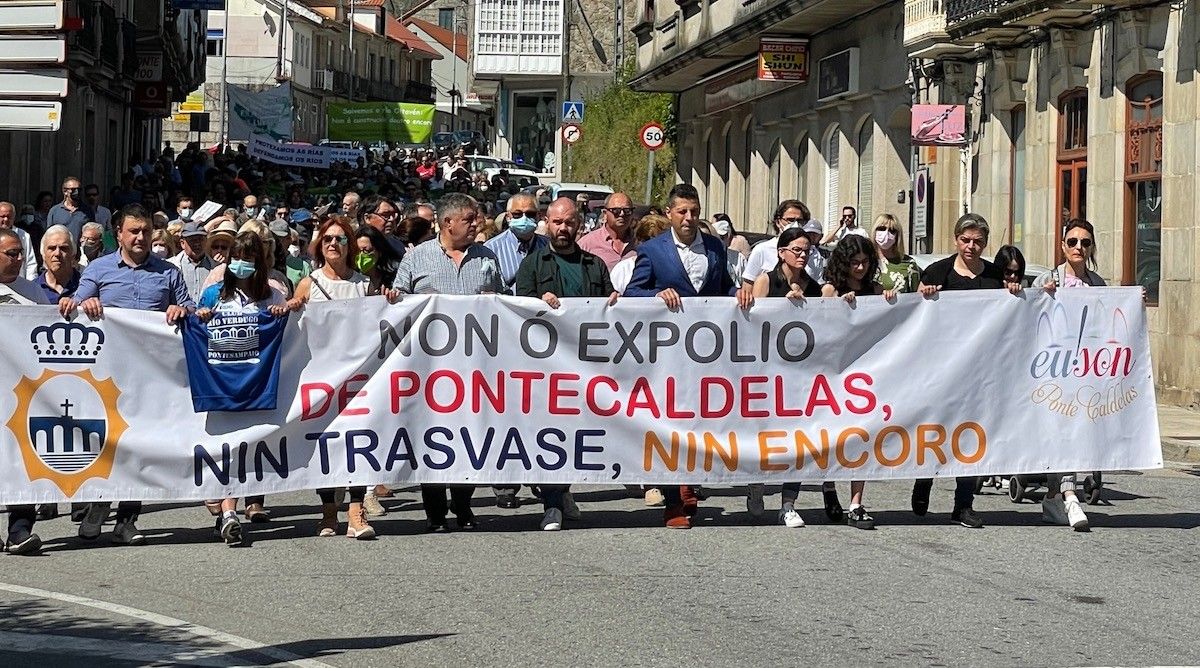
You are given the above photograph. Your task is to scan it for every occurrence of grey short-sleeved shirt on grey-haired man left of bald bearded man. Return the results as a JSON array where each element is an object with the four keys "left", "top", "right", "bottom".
[{"left": 391, "top": 239, "right": 504, "bottom": 295}]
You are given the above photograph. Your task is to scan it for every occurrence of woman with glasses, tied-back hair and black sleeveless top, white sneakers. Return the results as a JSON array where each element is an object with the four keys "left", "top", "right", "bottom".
[{"left": 746, "top": 228, "right": 825, "bottom": 529}]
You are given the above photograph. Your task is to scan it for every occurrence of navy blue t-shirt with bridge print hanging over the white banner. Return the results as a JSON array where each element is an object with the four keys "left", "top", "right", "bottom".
[{"left": 182, "top": 311, "right": 288, "bottom": 413}]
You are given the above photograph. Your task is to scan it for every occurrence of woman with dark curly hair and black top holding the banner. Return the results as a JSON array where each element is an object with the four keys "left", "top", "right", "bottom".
[{"left": 821, "top": 233, "right": 895, "bottom": 529}]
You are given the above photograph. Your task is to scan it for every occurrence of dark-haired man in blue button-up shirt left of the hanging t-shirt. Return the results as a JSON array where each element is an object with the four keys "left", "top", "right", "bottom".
[{"left": 59, "top": 204, "right": 196, "bottom": 544}]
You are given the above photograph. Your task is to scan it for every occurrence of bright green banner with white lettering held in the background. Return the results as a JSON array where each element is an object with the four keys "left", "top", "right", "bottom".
[{"left": 326, "top": 102, "right": 436, "bottom": 144}]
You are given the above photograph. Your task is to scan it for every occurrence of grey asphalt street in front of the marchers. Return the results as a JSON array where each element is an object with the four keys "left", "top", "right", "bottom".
[{"left": 0, "top": 465, "right": 1200, "bottom": 667}]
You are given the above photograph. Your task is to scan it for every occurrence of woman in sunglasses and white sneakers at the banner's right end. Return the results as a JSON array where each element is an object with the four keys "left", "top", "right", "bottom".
[{"left": 1033, "top": 218, "right": 1105, "bottom": 531}]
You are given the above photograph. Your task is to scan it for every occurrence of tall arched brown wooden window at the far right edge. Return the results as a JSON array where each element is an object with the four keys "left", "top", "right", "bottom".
[{"left": 1121, "top": 72, "right": 1163, "bottom": 303}]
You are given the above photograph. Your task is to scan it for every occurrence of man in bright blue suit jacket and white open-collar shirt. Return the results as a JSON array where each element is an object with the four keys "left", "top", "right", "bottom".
[{"left": 625, "top": 183, "right": 754, "bottom": 529}]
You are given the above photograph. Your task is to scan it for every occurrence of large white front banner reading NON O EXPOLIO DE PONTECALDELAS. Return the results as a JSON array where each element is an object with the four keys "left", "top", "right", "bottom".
[{"left": 0, "top": 288, "right": 1162, "bottom": 502}]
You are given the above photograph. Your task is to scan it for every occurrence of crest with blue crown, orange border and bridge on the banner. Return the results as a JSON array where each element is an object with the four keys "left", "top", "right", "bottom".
[{"left": 8, "top": 323, "right": 128, "bottom": 497}]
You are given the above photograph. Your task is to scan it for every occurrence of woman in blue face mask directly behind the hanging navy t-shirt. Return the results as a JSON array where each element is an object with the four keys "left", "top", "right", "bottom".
[{"left": 196, "top": 230, "right": 289, "bottom": 546}]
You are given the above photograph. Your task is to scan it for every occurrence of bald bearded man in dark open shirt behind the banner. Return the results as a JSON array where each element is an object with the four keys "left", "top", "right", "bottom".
[{"left": 514, "top": 197, "right": 617, "bottom": 531}]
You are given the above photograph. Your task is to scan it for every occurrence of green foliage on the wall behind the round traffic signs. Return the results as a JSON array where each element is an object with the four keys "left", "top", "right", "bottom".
[{"left": 566, "top": 77, "right": 676, "bottom": 204}]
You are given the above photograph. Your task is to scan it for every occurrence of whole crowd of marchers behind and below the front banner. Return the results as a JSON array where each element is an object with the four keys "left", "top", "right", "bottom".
[{"left": 0, "top": 146, "right": 1104, "bottom": 554}]
